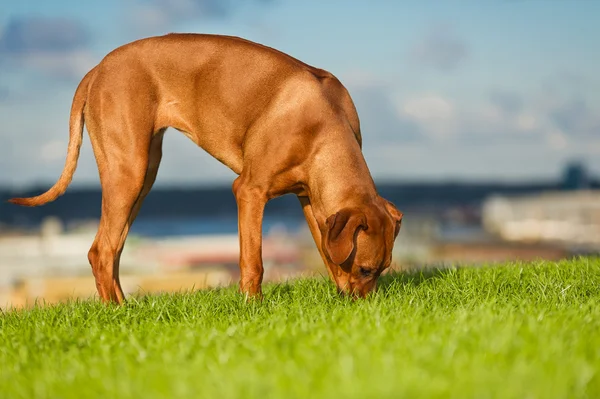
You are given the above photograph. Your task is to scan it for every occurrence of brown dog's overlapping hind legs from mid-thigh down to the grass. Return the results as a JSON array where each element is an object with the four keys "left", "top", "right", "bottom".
[{"left": 88, "top": 111, "right": 163, "bottom": 303}]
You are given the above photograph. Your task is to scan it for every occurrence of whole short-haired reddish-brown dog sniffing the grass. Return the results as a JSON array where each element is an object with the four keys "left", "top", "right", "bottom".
[{"left": 11, "top": 34, "right": 402, "bottom": 303}]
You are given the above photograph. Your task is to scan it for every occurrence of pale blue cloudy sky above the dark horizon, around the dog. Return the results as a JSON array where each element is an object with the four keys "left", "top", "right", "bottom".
[{"left": 0, "top": 0, "right": 600, "bottom": 189}]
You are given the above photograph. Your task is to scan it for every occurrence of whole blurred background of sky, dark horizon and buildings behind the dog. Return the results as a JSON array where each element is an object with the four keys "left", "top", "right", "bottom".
[{"left": 0, "top": 0, "right": 600, "bottom": 306}]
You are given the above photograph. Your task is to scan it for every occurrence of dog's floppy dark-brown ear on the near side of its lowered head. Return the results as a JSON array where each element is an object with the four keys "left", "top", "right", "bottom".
[{"left": 323, "top": 208, "right": 367, "bottom": 265}]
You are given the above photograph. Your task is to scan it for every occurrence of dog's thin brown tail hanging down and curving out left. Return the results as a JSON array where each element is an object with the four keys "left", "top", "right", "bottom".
[{"left": 8, "top": 68, "right": 96, "bottom": 206}]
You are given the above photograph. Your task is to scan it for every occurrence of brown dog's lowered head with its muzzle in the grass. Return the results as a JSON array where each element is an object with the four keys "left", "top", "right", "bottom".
[{"left": 321, "top": 197, "right": 402, "bottom": 297}]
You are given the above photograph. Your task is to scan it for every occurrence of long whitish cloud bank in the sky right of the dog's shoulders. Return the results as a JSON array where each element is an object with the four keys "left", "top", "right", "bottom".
[{"left": 396, "top": 87, "right": 600, "bottom": 150}]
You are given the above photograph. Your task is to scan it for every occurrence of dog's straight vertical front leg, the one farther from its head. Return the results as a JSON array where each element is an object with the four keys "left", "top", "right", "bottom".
[{"left": 233, "top": 176, "right": 267, "bottom": 297}]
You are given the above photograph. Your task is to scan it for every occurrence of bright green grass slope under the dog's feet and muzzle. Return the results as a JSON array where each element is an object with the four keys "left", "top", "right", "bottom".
[{"left": 0, "top": 258, "right": 600, "bottom": 398}]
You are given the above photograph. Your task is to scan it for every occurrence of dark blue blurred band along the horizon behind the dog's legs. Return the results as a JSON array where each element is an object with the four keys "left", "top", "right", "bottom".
[{"left": 0, "top": 181, "right": 600, "bottom": 226}]
